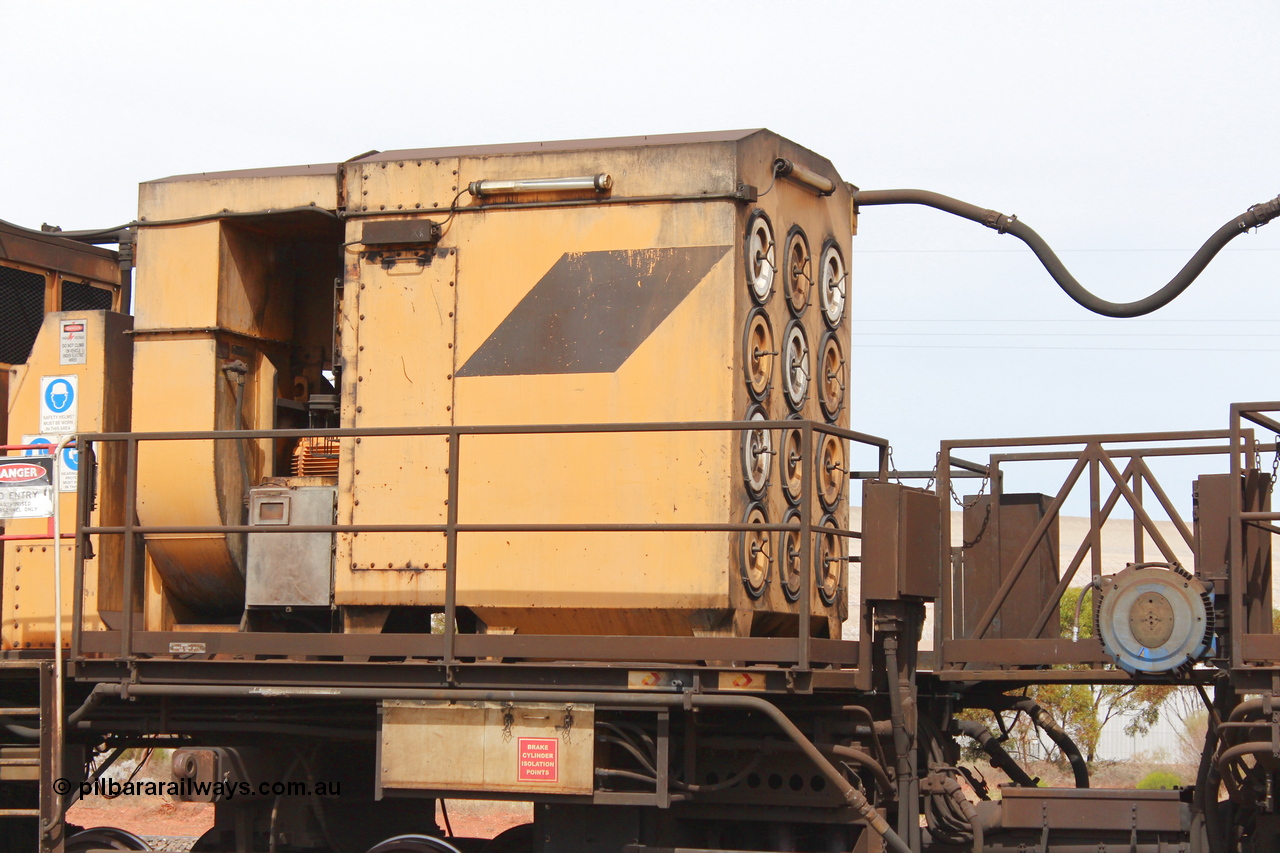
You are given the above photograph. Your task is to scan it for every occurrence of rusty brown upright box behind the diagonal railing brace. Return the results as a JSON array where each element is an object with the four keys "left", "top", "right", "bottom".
[{"left": 959, "top": 494, "right": 1059, "bottom": 639}]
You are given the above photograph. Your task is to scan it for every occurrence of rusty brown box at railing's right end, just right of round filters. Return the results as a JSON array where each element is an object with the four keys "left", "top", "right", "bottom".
[{"left": 861, "top": 482, "right": 941, "bottom": 601}]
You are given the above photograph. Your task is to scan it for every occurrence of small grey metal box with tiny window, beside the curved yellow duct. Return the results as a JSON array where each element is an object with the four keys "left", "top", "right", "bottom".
[{"left": 244, "top": 485, "right": 338, "bottom": 607}]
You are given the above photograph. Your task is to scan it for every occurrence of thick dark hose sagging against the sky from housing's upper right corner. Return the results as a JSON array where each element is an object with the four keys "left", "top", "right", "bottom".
[{"left": 854, "top": 190, "right": 1280, "bottom": 316}]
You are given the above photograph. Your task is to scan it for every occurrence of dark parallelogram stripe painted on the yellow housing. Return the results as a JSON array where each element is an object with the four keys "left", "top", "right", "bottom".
[{"left": 457, "top": 246, "right": 730, "bottom": 377}]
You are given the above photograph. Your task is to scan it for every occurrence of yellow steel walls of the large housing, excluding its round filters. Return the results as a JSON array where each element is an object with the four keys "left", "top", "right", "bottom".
[{"left": 124, "top": 131, "right": 852, "bottom": 634}]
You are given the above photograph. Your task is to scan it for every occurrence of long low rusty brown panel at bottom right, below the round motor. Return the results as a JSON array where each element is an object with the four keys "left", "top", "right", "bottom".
[{"left": 1001, "top": 788, "right": 1190, "bottom": 833}]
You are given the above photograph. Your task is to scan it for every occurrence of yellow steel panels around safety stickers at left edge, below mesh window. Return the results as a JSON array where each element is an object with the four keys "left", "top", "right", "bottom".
[{"left": 0, "top": 311, "right": 132, "bottom": 649}]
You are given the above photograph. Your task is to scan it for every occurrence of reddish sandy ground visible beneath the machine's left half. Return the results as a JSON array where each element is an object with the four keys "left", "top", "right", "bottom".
[{"left": 67, "top": 797, "right": 532, "bottom": 838}]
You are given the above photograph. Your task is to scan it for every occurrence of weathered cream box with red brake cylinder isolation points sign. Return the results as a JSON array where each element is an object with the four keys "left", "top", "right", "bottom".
[{"left": 378, "top": 699, "right": 595, "bottom": 795}]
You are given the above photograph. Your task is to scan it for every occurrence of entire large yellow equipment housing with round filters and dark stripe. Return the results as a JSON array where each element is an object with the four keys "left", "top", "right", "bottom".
[{"left": 133, "top": 131, "right": 854, "bottom": 635}]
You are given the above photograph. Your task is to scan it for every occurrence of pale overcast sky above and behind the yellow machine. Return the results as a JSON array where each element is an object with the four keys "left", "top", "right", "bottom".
[{"left": 0, "top": 0, "right": 1280, "bottom": 507}]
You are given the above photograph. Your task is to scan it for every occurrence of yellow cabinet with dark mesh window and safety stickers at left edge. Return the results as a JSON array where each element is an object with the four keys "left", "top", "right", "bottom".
[{"left": 0, "top": 223, "right": 132, "bottom": 653}]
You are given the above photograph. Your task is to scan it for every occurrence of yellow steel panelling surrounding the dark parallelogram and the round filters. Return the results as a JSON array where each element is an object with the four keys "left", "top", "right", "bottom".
[{"left": 335, "top": 133, "right": 852, "bottom": 634}]
